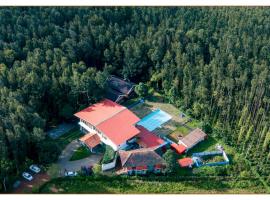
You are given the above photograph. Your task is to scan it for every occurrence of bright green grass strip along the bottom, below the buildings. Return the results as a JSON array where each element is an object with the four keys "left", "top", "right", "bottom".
[{"left": 39, "top": 176, "right": 266, "bottom": 194}]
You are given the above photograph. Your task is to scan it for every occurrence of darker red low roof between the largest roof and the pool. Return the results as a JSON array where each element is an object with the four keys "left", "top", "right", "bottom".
[{"left": 137, "top": 126, "right": 165, "bottom": 148}]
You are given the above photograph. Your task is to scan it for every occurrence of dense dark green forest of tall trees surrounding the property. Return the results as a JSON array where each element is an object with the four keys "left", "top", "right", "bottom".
[{"left": 0, "top": 7, "right": 270, "bottom": 190}]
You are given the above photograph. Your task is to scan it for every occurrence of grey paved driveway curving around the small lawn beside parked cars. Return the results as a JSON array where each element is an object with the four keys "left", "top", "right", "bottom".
[{"left": 58, "top": 140, "right": 102, "bottom": 173}]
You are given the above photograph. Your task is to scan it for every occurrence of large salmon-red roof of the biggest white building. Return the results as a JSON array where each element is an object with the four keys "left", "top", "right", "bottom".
[{"left": 75, "top": 99, "right": 140, "bottom": 145}]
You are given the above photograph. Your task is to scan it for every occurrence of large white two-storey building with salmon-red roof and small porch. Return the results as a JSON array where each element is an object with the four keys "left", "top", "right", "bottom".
[{"left": 75, "top": 99, "right": 140, "bottom": 151}]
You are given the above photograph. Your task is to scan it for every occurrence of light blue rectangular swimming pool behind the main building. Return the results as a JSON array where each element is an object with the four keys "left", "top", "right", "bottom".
[{"left": 137, "top": 109, "right": 172, "bottom": 131}]
